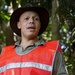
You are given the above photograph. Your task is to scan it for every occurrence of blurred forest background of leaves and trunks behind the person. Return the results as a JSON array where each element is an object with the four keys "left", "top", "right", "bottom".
[{"left": 0, "top": 0, "right": 75, "bottom": 75}]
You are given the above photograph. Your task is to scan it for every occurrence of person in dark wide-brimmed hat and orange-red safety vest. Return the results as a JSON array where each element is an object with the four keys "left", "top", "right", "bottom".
[{"left": 0, "top": 5, "right": 68, "bottom": 75}]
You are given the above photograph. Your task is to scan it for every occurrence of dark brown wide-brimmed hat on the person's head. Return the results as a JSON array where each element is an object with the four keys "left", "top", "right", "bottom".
[{"left": 10, "top": 6, "right": 49, "bottom": 36}]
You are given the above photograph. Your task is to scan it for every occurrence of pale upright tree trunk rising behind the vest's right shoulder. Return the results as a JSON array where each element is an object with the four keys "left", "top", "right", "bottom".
[{"left": 51, "top": 0, "right": 60, "bottom": 40}]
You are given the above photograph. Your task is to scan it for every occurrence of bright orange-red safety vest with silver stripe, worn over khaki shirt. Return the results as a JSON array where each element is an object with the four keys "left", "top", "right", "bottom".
[{"left": 0, "top": 41, "right": 59, "bottom": 75}]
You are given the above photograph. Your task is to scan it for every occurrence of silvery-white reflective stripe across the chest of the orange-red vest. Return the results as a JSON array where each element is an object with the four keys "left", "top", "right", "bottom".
[{"left": 0, "top": 62, "right": 52, "bottom": 73}]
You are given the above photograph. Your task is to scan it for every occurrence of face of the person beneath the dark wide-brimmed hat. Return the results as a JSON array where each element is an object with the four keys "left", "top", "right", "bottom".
[{"left": 17, "top": 11, "right": 41, "bottom": 38}]
